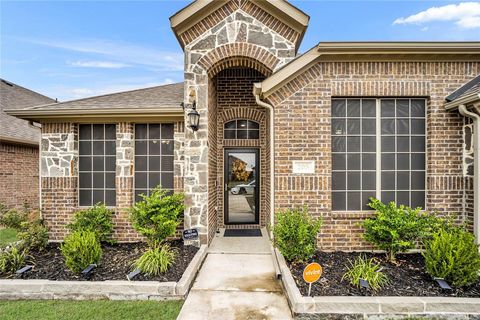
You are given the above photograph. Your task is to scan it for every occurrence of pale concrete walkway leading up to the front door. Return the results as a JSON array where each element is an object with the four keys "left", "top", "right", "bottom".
[{"left": 177, "top": 230, "right": 292, "bottom": 320}]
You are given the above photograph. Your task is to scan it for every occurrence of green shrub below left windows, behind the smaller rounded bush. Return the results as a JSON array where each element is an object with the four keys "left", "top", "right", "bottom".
[{"left": 67, "top": 203, "right": 114, "bottom": 243}]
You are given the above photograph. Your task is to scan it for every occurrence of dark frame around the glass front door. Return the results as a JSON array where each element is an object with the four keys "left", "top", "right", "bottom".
[{"left": 223, "top": 147, "right": 261, "bottom": 226}]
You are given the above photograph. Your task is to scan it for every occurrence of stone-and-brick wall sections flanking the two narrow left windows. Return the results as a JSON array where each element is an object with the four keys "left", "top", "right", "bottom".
[{"left": 41, "top": 121, "right": 184, "bottom": 242}]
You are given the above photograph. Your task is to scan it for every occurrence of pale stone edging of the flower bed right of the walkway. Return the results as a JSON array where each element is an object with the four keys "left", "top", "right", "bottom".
[{"left": 275, "top": 249, "right": 480, "bottom": 315}]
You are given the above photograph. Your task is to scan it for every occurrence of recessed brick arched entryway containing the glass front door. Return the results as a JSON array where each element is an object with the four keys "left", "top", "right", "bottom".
[{"left": 208, "top": 62, "right": 271, "bottom": 235}]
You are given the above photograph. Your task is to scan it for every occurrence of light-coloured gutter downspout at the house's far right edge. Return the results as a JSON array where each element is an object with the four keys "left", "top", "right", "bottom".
[{"left": 458, "top": 104, "right": 480, "bottom": 245}]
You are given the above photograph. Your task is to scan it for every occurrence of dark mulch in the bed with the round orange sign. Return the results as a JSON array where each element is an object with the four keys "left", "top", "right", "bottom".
[{"left": 289, "top": 251, "right": 480, "bottom": 297}]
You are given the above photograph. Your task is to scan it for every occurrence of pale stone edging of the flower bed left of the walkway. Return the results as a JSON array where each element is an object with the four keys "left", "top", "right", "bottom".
[{"left": 0, "top": 245, "right": 207, "bottom": 300}]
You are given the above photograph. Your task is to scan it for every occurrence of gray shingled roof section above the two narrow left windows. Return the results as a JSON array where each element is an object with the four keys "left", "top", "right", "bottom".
[{"left": 23, "top": 82, "right": 183, "bottom": 111}]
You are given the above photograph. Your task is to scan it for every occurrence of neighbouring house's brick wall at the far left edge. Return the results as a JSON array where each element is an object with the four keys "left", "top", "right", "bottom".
[{"left": 0, "top": 142, "right": 39, "bottom": 208}]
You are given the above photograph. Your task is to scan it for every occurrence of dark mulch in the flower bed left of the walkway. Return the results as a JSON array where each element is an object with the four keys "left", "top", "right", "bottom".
[{"left": 2, "top": 241, "right": 198, "bottom": 282}]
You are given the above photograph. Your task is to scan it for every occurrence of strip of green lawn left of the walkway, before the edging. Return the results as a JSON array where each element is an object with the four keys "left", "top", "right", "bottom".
[{"left": 0, "top": 300, "right": 183, "bottom": 320}]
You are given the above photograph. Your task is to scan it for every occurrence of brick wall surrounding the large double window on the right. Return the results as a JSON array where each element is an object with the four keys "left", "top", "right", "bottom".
[{"left": 268, "top": 62, "right": 480, "bottom": 250}]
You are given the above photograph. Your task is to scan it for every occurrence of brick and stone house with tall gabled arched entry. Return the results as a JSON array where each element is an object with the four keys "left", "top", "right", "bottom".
[{"left": 7, "top": 0, "right": 480, "bottom": 250}]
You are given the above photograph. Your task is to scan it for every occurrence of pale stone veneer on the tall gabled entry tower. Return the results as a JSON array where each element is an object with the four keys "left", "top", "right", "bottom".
[{"left": 179, "top": 1, "right": 300, "bottom": 243}]
